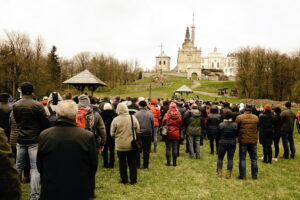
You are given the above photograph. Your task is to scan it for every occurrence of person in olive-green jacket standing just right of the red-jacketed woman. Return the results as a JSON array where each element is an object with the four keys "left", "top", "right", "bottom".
[{"left": 183, "top": 104, "right": 202, "bottom": 159}]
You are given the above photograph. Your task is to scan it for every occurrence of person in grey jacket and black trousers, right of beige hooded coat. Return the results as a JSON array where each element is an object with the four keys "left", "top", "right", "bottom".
[{"left": 134, "top": 101, "right": 154, "bottom": 169}]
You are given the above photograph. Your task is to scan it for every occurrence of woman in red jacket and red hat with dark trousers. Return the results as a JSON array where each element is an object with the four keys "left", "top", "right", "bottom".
[{"left": 162, "top": 102, "right": 182, "bottom": 166}]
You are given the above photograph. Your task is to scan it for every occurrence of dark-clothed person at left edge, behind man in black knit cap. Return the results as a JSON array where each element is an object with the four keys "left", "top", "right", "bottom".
[{"left": 0, "top": 93, "right": 12, "bottom": 141}]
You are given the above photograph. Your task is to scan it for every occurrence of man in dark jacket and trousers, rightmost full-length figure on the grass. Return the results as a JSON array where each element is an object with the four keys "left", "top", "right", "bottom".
[{"left": 280, "top": 102, "right": 296, "bottom": 159}]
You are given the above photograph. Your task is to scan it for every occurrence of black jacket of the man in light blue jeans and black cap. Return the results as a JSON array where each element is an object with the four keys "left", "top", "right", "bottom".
[{"left": 13, "top": 95, "right": 49, "bottom": 144}]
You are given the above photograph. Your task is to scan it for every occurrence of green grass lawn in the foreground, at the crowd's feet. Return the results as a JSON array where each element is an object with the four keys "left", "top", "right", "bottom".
[{"left": 22, "top": 133, "right": 300, "bottom": 200}]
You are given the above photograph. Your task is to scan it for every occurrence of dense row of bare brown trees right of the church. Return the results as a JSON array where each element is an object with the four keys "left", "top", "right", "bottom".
[{"left": 236, "top": 47, "right": 300, "bottom": 102}]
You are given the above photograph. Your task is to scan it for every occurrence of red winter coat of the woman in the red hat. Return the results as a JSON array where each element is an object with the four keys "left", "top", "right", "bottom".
[{"left": 162, "top": 110, "right": 182, "bottom": 140}]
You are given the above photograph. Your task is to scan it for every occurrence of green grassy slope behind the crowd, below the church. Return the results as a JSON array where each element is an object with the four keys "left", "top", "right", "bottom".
[{"left": 96, "top": 76, "right": 234, "bottom": 99}]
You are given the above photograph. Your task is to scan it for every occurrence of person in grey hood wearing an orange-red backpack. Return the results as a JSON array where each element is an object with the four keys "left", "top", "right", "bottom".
[{"left": 76, "top": 94, "right": 106, "bottom": 198}]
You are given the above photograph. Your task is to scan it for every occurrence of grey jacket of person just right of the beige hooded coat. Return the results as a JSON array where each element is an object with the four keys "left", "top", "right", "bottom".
[{"left": 134, "top": 108, "right": 154, "bottom": 136}]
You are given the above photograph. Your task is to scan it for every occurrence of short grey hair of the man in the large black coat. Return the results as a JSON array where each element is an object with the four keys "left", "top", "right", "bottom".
[{"left": 56, "top": 100, "right": 78, "bottom": 120}]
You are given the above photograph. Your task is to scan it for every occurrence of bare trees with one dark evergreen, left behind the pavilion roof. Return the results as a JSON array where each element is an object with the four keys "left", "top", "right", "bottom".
[{"left": 0, "top": 32, "right": 141, "bottom": 97}]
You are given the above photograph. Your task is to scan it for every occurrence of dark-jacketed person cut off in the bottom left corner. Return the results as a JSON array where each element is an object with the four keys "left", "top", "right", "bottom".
[{"left": 0, "top": 129, "right": 21, "bottom": 200}]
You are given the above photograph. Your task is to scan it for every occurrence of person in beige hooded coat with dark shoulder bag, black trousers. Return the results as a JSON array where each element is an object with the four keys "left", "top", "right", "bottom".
[{"left": 110, "top": 103, "right": 140, "bottom": 184}]
